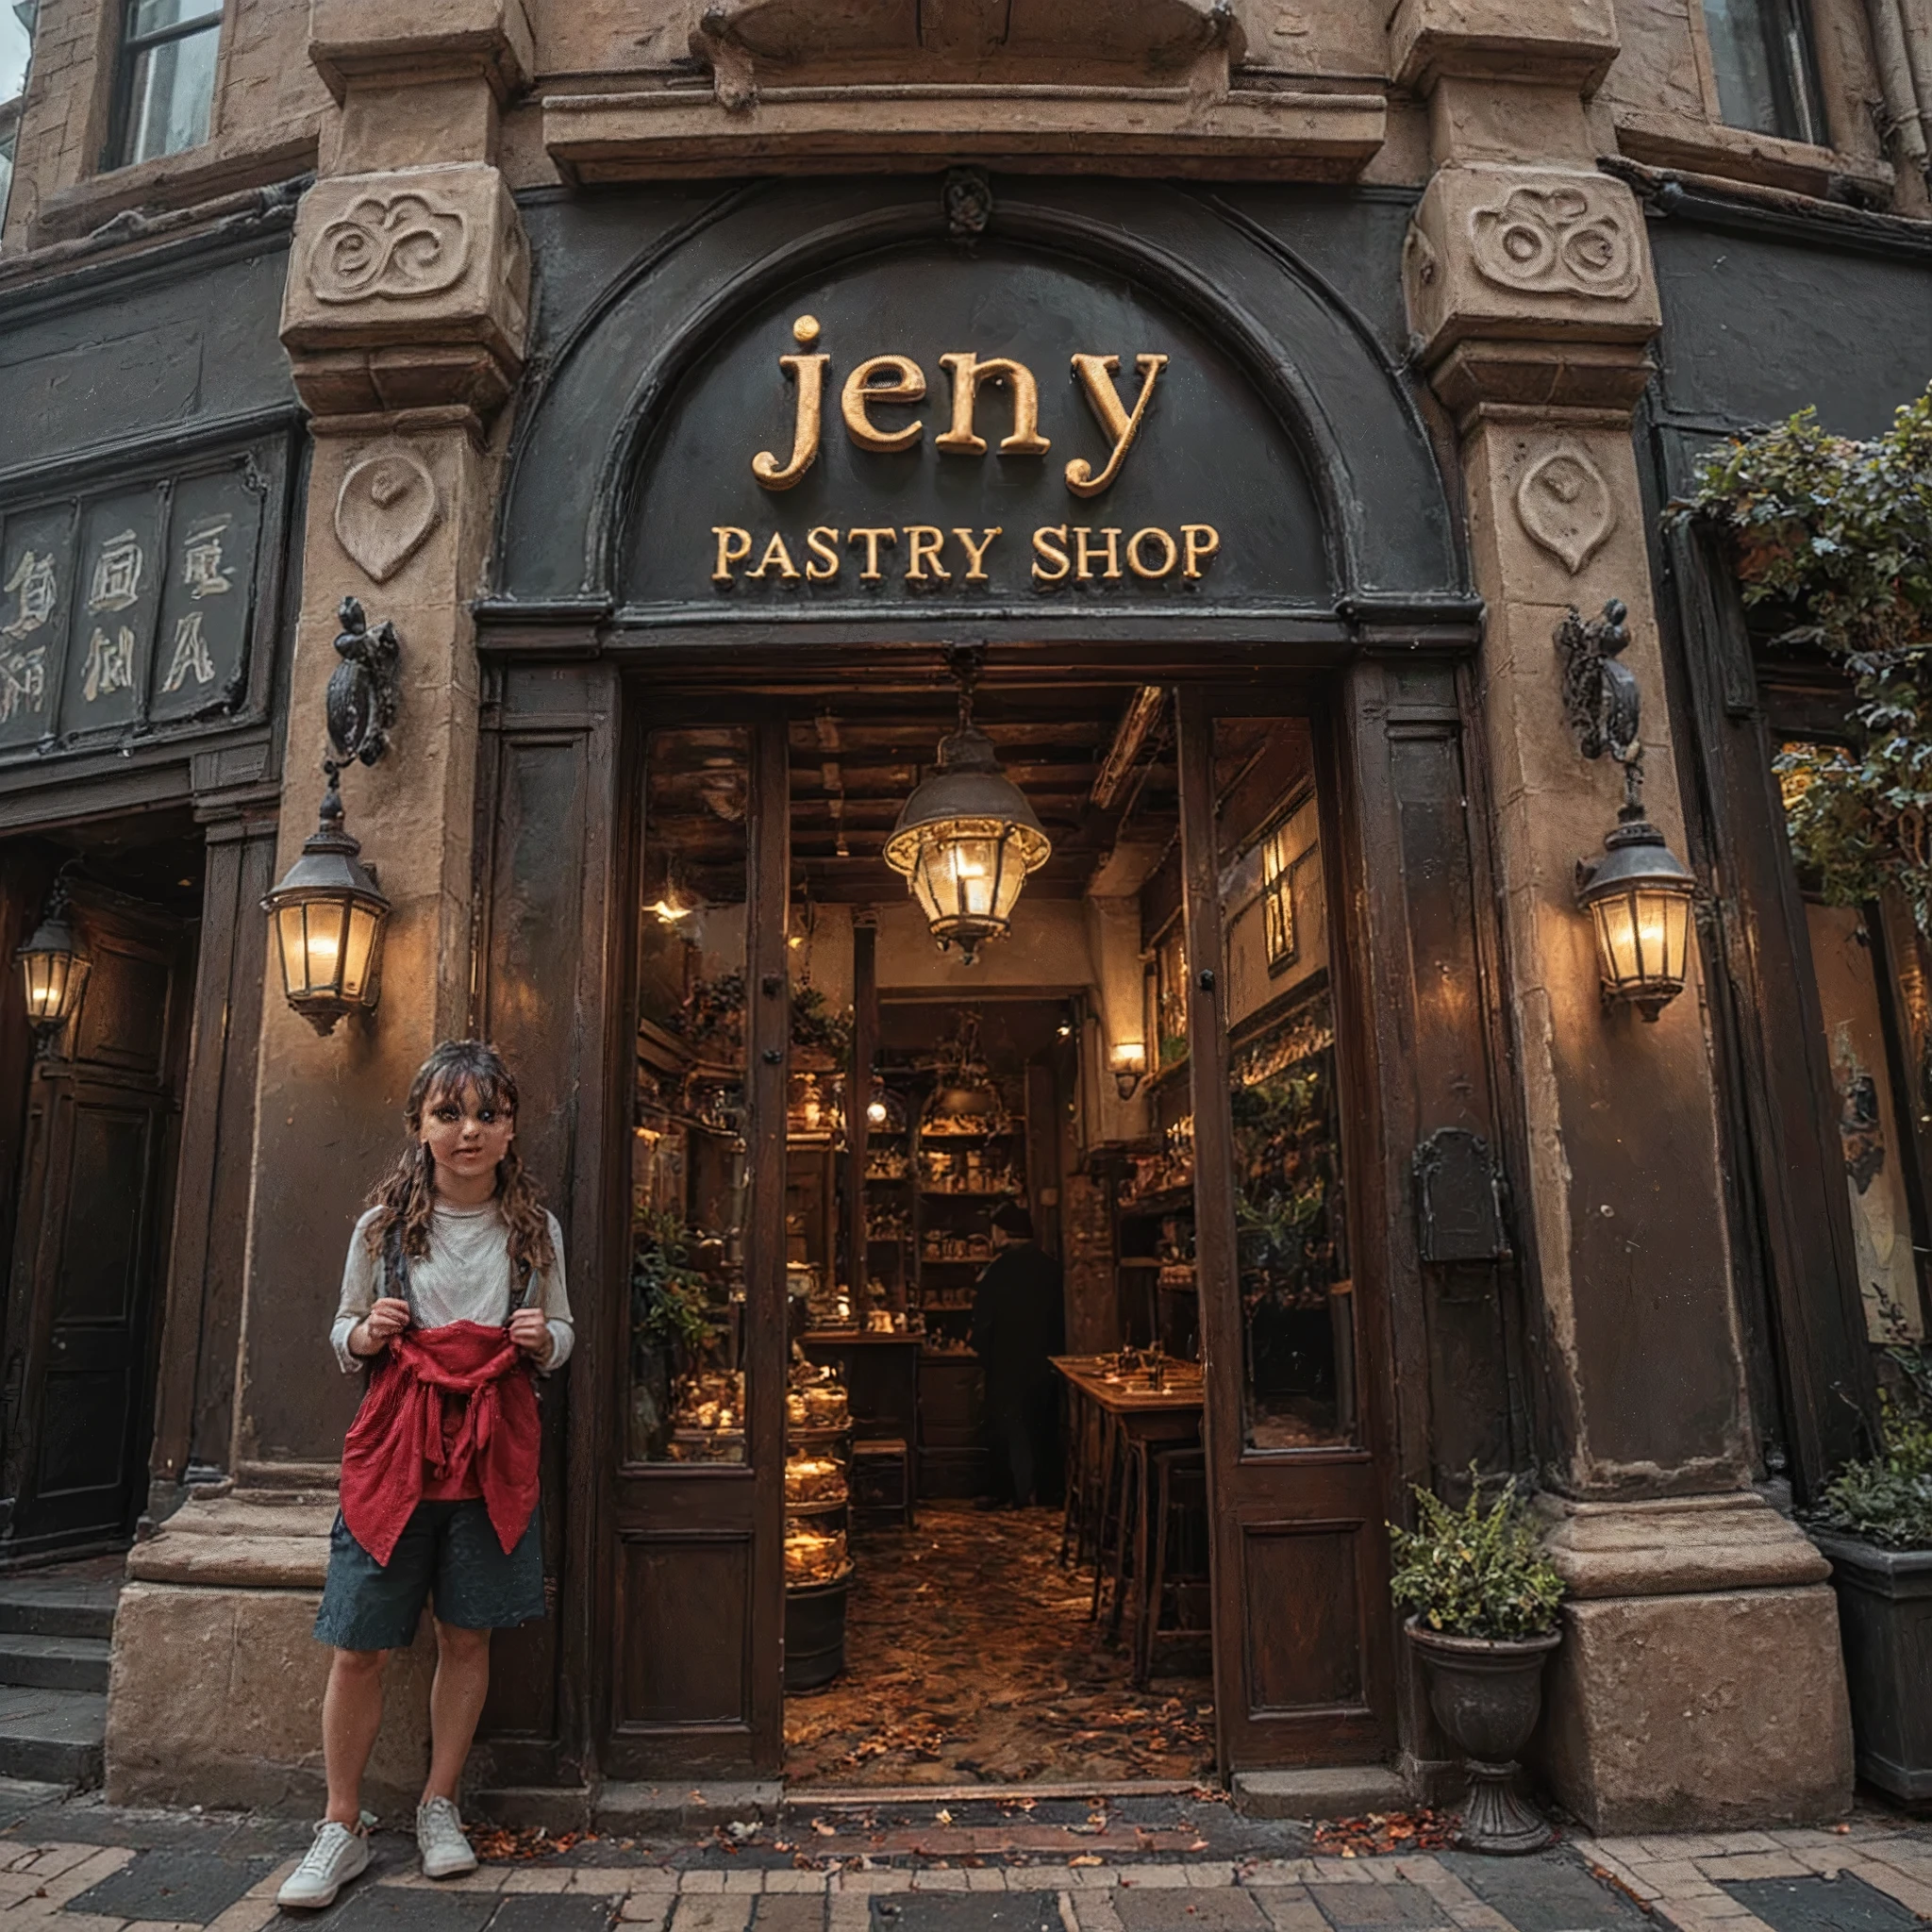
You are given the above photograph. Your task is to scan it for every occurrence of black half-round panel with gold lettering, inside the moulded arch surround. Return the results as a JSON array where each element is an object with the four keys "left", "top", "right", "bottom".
[{"left": 618, "top": 247, "right": 1335, "bottom": 620}]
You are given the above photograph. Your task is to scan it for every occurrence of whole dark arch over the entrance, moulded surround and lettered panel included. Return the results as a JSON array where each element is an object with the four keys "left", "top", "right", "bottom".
[{"left": 477, "top": 177, "right": 1476, "bottom": 649}]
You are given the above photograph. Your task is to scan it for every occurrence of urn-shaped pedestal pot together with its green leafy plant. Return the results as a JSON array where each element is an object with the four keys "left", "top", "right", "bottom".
[{"left": 1390, "top": 1464, "right": 1563, "bottom": 1853}]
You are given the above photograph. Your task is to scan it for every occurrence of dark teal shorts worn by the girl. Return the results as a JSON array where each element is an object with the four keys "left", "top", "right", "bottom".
[{"left": 315, "top": 1497, "right": 545, "bottom": 1650}]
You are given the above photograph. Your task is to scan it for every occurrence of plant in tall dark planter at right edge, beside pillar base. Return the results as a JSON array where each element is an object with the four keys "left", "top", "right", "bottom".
[{"left": 1810, "top": 1344, "right": 1932, "bottom": 1799}]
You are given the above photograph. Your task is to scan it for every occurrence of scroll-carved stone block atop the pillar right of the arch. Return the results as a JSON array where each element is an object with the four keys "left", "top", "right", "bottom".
[{"left": 1403, "top": 166, "right": 1663, "bottom": 382}]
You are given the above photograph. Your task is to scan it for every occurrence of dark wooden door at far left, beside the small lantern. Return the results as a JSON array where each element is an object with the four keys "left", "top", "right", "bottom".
[{"left": 0, "top": 887, "right": 193, "bottom": 1554}]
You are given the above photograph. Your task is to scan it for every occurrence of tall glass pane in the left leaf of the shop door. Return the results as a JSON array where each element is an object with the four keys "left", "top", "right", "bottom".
[{"left": 626, "top": 728, "right": 750, "bottom": 1462}]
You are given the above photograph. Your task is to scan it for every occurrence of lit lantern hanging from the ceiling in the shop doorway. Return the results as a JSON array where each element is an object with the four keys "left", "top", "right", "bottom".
[{"left": 885, "top": 669, "right": 1053, "bottom": 966}]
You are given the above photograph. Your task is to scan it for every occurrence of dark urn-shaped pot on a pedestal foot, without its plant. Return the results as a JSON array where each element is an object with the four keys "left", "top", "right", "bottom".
[{"left": 1405, "top": 1617, "right": 1563, "bottom": 1857}]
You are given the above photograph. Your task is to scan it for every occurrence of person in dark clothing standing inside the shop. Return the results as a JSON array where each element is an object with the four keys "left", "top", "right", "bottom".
[{"left": 972, "top": 1202, "right": 1066, "bottom": 1508}]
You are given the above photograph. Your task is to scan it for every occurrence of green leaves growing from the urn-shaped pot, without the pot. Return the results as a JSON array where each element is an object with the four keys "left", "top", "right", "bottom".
[{"left": 1390, "top": 1462, "right": 1563, "bottom": 1639}]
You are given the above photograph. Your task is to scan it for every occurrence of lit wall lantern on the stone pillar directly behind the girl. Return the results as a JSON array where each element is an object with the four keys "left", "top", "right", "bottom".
[{"left": 260, "top": 761, "right": 391, "bottom": 1038}]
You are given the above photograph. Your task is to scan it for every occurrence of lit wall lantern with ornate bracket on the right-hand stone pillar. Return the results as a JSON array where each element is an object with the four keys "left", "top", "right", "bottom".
[{"left": 1556, "top": 599, "right": 1696, "bottom": 1020}]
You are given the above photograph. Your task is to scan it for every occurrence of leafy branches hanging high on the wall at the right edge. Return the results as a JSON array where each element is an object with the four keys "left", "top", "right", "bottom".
[{"left": 1674, "top": 391, "right": 1932, "bottom": 937}]
